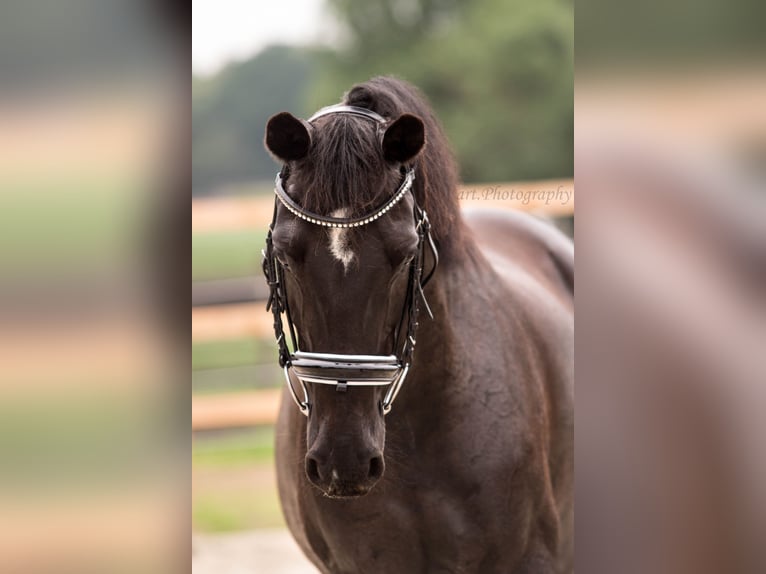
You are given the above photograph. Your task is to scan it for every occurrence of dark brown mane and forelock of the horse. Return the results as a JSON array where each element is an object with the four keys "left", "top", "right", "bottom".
[{"left": 303, "top": 77, "right": 464, "bottom": 258}]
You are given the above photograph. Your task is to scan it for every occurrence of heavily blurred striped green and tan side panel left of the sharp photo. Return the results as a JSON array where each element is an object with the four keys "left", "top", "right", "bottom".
[{"left": 0, "top": 0, "right": 190, "bottom": 572}]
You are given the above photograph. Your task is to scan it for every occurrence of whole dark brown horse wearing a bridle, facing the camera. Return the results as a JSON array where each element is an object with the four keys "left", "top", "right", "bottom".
[{"left": 264, "top": 77, "right": 574, "bottom": 574}]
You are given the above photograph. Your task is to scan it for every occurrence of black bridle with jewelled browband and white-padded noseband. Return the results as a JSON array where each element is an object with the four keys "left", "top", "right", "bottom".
[{"left": 263, "top": 105, "right": 439, "bottom": 416}]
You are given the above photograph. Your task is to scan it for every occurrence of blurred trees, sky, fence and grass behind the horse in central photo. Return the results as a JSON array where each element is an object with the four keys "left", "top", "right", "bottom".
[{"left": 192, "top": 0, "right": 574, "bottom": 560}]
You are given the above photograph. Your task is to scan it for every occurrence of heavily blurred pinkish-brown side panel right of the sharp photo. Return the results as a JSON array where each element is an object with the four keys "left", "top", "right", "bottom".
[{"left": 575, "top": 0, "right": 766, "bottom": 574}]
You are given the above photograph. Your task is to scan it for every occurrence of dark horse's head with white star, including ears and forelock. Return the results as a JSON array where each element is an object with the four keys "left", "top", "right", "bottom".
[{"left": 265, "top": 106, "right": 425, "bottom": 497}]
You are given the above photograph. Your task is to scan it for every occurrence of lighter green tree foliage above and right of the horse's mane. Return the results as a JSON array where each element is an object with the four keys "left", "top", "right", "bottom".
[{"left": 312, "top": 0, "right": 574, "bottom": 182}]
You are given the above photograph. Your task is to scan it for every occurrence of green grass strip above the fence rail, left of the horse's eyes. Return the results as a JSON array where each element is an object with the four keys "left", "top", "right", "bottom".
[{"left": 192, "top": 229, "right": 266, "bottom": 281}]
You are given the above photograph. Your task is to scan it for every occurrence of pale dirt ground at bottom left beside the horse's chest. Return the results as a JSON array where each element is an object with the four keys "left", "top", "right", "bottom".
[{"left": 192, "top": 530, "right": 317, "bottom": 574}]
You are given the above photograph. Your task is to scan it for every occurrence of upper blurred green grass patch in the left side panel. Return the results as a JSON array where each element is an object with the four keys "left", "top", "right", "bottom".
[{"left": 0, "top": 178, "right": 148, "bottom": 277}]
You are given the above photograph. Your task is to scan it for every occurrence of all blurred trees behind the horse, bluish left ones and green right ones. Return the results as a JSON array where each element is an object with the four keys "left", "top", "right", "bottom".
[{"left": 193, "top": 0, "right": 574, "bottom": 193}]
